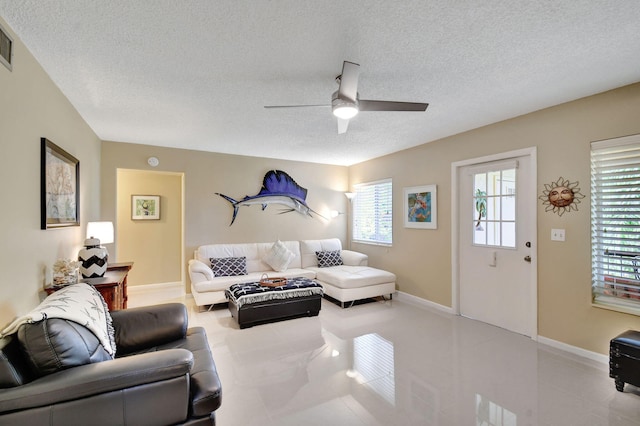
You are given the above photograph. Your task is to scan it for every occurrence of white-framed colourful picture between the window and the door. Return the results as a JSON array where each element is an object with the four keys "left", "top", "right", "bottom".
[{"left": 402, "top": 185, "right": 438, "bottom": 229}]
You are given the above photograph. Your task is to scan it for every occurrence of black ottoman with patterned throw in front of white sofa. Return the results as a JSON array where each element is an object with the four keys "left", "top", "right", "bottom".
[{"left": 225, "top": 277, "right": 323, "bottom": 328}]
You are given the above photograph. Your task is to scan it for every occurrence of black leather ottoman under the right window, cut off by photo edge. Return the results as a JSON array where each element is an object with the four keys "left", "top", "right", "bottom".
[{"left": 609, "top": 330, "right": 640, "bottom": 392}]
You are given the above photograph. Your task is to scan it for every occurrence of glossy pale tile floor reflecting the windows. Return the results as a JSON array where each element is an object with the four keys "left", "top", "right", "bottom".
[{"left": 130, "top": 293, "right": 640, "bottom": 426}]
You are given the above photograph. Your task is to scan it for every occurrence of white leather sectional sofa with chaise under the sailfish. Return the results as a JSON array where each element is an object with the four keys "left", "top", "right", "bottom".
[{"left": 189, "top": 238, "right": 396, "bottom": 307}]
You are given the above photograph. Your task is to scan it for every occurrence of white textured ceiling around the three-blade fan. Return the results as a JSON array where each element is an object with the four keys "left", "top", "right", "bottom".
[{"left": 0, "top": 0, "right": 640, "bottom": 165}]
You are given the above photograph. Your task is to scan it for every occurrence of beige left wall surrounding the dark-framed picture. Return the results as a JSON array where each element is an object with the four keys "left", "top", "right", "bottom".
[{"left": 0, "top": 19, "right": 100, "bottom": 327}]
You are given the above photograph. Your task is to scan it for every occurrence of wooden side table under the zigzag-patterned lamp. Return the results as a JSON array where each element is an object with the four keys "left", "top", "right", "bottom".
[{"left": 44, "top": 262, "right": 133, "bottom": 311}]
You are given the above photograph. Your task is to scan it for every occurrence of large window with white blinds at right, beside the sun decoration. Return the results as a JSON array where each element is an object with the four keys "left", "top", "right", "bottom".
[{"left": 591, "top": 135, "right": 640, "bottom": 314}]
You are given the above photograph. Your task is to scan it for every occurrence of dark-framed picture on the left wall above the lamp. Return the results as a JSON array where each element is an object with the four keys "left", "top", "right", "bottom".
[{"left": 40, "top": 138, "right": 80, "bottom": 229}]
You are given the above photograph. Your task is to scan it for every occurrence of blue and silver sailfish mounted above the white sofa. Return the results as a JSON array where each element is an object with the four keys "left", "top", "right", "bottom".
[{"left": 216, "top": 170, "right": 320, "bottom": 226}]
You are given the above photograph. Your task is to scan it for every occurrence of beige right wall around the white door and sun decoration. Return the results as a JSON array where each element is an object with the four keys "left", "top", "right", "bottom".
[{"left": 349, "top": 84, "right": 640, "bottom": 354}]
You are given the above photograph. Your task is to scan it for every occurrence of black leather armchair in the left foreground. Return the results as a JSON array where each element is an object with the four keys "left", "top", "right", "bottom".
[{"left": 0, "top": 303, "right": 222, "bottom": 426}]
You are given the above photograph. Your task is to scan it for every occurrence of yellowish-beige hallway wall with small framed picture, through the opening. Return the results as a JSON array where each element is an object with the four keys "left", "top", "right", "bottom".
[{"left": 115, "top": 169, "right": 183, "bottom": 285}]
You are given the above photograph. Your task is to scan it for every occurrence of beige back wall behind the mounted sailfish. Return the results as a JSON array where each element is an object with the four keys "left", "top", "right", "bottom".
[{"left": 101, "top": 142, "right": 348, "bottom": 292}]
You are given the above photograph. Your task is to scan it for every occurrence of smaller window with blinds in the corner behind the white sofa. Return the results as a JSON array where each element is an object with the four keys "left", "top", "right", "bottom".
[{"left": 352, "top": 179, "right": 393, "bottom": 245}]
